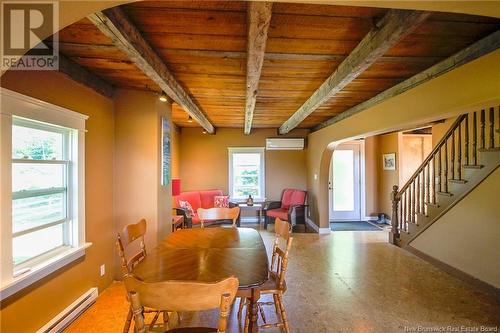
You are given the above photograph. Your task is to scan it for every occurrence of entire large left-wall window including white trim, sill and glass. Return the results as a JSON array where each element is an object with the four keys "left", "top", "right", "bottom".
[{"left": 0, "top": 88, "right": 90, "bottom": 299}]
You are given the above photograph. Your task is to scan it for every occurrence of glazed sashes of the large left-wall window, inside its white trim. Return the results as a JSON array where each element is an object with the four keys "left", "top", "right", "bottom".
[{"left": 12, "top": 117, "right": 72, "bottom": 266}]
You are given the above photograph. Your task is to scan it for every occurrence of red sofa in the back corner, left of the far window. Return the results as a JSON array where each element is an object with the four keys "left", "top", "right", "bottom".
[{"left": 174, "top": 190, "right": 240, "bottom": 228}]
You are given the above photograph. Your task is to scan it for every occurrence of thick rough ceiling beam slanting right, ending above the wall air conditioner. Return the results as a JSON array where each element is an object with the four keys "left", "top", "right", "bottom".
[{"left": 279, "top": 10, "right": 430, "bottom": 134}]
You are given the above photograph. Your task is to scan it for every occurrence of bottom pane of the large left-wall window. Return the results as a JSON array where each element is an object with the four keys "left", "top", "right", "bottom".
[{"left": 12, "top": 224, "right": 64, "bottom": 265}]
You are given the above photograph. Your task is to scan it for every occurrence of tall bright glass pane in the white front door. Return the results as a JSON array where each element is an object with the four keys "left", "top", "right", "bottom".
[{"left": 333, "top": 150, "right": 355, "bottom": 211}]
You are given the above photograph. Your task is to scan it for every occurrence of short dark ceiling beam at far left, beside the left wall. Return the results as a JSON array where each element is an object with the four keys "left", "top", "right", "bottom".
[{"left": 59, "top": 53, "right": 115, "bottom": 98}]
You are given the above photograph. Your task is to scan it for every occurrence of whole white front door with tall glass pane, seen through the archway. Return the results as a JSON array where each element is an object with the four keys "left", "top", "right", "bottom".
[{"left": 330, "top": 144, "right": 361, "bottom": 221}]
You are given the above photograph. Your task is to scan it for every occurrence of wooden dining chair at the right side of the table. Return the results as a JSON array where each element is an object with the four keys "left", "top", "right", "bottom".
[{"left": 238, "top": 218, "right": 293, "bottom": 333}]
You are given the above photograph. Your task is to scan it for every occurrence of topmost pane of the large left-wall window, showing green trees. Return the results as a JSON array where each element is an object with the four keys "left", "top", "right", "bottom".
[{"left": 12, "top": 125, "right": 64, "bottom": 160}]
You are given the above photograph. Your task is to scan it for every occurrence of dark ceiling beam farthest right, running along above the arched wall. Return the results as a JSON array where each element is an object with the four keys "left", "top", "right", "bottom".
[{"left": 312, "top": 30, "right": 500, "bottom": 132}]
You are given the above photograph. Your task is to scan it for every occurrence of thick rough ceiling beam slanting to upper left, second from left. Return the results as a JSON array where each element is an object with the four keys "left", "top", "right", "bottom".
[{"left": 88, "top": 7, "right": 215, "bottom": 134}]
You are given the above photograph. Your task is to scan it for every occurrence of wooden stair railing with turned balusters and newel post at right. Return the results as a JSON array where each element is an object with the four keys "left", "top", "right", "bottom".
[{"left": 389, "top": 107, "right": 500, "bottom": 244}]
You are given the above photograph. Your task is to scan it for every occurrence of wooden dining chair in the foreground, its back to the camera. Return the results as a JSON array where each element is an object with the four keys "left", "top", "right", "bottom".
[{"left": 125, "top": 275, "right": 239, "bottom": 333}]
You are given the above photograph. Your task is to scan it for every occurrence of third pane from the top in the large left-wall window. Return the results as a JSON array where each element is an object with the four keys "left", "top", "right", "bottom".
[{"left": 12, "top": 193, "right": 66, "bottom": 233}]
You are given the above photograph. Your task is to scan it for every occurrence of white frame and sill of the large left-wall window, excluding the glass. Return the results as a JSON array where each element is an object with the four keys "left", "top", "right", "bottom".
[{"left": 0, "top": 88, "right": 91, "bottom": 300}]
